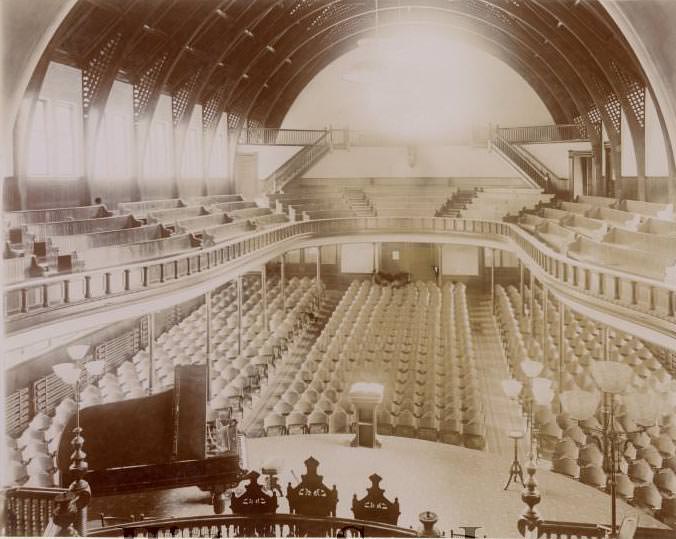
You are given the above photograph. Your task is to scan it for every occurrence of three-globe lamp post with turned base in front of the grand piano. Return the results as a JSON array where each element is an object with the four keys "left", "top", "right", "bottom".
[{"left": 52, "top": 345, "right": 104, "bottom": 535}]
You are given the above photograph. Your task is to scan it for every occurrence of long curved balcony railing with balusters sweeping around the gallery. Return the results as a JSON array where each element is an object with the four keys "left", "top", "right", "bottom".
[{"left": 5, "top": 217, "right": 676, "bottom": 335}]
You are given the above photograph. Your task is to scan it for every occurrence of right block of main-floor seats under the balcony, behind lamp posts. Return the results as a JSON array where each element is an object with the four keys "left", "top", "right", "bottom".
[{"left": 496, "top": 286, "right": 676, "bottom": 523}]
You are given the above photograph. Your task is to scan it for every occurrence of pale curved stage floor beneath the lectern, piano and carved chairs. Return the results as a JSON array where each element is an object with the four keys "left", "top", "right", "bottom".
[{"left": 89, "top": 434, "right": 666, "bottom": 537}]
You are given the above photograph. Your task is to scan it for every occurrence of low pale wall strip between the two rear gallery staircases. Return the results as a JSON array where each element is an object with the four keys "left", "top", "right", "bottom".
[{"left": 304, "top": 146, "right": 517, "bottom": 178}]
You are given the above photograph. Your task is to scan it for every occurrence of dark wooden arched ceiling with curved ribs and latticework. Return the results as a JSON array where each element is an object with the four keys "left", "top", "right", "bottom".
[{"left": 36, "top": 0, "right": 646, "bottom": 143}]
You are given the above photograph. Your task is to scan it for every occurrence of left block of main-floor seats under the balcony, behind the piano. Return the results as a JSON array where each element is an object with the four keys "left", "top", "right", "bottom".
[{"left": 6, "top": 278, "right": 316, "bottom": 487}]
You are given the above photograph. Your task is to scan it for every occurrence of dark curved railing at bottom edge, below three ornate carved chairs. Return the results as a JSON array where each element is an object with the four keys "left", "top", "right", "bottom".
[{"left": 87, "top": 513, "right": 418, "bottom": 538}]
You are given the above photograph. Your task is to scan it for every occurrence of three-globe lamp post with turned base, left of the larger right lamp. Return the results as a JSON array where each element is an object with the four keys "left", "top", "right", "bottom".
[{"left": 502, "top": 359, "right": 554, "bottom": 537}]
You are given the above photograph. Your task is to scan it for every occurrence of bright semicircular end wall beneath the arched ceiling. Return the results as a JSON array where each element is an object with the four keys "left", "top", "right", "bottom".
[{"left": 283, "top": 28, "right": 552, "bottom": 140}]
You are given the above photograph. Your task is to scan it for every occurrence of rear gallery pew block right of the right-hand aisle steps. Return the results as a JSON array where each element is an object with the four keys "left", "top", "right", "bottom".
[{"left": 460, "top": 188, "right": 553, "bottom": 221}]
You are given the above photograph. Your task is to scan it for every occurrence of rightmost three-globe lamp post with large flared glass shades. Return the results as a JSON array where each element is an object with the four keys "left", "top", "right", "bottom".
[{"left": 561, "top": 361, "right": 661, "bottom": 539}]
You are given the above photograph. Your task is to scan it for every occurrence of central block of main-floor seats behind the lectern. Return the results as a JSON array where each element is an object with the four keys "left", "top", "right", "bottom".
[{"left": 255, "top": 281, "right": 485, "bottom": 448}]
